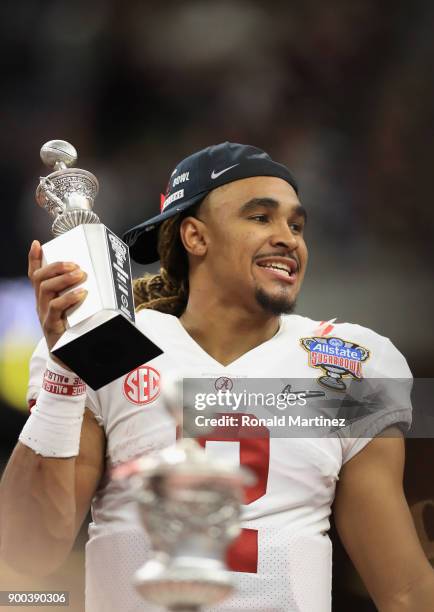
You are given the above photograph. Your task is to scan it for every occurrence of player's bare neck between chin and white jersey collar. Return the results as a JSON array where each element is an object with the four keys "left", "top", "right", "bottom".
[{"left": 179, "top": 301, "right": 280, "bottom": 366}]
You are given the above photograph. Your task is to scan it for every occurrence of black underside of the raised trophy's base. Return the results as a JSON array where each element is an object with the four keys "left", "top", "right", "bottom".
[{"left": 51, "top": 311, "right": 163, "bottom": 391}]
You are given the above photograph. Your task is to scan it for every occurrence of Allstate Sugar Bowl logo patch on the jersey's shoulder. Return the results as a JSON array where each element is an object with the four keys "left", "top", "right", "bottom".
[{"left": 300, "top": 337, "right": 370, "bottom": 391}]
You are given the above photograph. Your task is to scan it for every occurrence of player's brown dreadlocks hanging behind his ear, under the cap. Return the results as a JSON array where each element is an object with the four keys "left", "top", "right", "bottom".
[{"left": 133, "top": 203, "right": 200, "bottom": 317}]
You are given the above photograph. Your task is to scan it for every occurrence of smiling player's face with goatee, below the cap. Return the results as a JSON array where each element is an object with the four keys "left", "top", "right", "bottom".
[{"left": 186, "top": 177, "right": 307, "bottom": 315}]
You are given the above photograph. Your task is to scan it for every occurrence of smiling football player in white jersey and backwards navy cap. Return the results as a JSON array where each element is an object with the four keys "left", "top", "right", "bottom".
[{"left": 1, "top": 143, "right": 434, "bottom": 612}]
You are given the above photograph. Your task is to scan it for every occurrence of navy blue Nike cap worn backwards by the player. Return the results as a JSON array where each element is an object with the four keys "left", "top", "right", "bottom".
[{"left": 123, "top": 142, "right": 298, "bottom": 264}]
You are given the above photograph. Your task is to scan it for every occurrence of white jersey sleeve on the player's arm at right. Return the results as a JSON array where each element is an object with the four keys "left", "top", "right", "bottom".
[{"left": 339, "top": 338, "right": 413, "bottom": 464}]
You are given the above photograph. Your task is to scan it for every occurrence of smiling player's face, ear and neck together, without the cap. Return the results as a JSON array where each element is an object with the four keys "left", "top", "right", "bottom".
[{"left": 176, "top": 176, "right": 307, "bottom": 365}]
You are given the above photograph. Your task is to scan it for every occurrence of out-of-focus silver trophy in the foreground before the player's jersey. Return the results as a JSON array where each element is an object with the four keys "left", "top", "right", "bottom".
[{"left": 114, "top": 380, "right": 255, "bottom": 612}]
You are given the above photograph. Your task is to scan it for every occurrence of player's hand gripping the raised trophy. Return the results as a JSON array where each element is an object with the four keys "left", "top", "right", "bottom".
[{"left": 28, "top": 240, "right": 87, "bottom": 351}]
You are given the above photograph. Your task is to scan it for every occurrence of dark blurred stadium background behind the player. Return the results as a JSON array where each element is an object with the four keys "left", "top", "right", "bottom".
[{"left": 0, "top": 0, "right": 434, "bottom": 612}]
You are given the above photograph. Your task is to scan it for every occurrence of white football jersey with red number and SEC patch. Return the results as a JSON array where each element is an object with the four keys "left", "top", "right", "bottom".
[{"left": 28, "top": 310, "right": 411, "bottom": 612}]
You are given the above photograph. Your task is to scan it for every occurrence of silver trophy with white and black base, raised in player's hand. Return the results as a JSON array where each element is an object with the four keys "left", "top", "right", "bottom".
[{"left": 36, "top": 140, "right": 162, "bottom": 389}]
